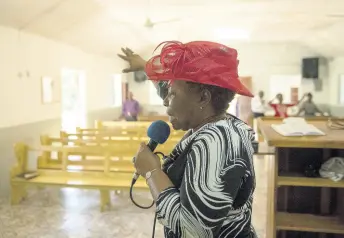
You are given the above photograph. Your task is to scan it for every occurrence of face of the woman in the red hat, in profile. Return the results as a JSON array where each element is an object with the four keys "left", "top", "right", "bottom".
[{"left": 164, "top": 80, "right": 204, "bottom": 131}]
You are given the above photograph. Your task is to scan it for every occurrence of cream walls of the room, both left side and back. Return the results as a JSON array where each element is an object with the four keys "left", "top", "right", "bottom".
[{"left": 0, "top": 24, "right": 344, "bottom": 127}]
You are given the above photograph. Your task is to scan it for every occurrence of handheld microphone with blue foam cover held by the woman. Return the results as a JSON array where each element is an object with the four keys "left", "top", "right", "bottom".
[{"left": 132, "top": 120, "right": 171, "bottom": 183}]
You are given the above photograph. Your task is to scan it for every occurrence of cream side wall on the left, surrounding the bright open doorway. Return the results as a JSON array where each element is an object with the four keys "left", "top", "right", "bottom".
[{"left": 0, "top": 26, "right": 123, "bottom": 127}]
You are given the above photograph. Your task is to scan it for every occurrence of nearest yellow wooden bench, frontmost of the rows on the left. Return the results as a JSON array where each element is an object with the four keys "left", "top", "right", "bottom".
[{"left": 10, "top": 143, "right": 148, "bottom": 211}]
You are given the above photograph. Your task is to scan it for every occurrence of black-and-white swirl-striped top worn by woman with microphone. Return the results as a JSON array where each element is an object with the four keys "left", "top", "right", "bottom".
[{"left": 156, "top": 117, "right": 256, "bottom": 238}]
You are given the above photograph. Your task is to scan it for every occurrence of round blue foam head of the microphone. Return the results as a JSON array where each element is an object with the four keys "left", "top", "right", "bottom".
[{"left": 147, "top": 120, "right": 171, "bottom": 144}]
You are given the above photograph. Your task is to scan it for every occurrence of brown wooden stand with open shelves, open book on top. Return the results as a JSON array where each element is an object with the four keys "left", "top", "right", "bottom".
[{"left": 258, "top": 118, "right": 344, "bottom": 238}]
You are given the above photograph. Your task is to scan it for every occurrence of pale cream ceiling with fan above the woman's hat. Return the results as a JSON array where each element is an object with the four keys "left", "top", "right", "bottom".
[{"left": 0, "top": 0, "right": 344, "bottom": 57}]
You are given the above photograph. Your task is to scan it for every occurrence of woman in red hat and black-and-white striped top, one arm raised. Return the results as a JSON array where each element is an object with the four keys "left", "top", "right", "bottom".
[{"left": 121, "top": 42, "right": 256, "bottom": 238}]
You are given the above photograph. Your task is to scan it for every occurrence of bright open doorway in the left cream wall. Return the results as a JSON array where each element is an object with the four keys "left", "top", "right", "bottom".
[{"left": 61, "top": 69, "right": 87, "bottom": 132}]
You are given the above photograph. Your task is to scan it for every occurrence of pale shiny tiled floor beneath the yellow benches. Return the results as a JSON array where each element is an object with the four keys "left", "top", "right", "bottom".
[{"left": 0, "top": 157, "right": 266, "bottom": 238}]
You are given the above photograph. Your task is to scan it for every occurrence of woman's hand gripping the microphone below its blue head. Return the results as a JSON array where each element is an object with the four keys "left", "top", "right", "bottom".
[{"left": 134, "top": 143, "right": 161, "bottom": 177}]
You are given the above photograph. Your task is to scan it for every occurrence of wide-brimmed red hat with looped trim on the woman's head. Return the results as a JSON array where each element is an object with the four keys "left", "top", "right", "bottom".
[{"left": 145, "top": 41, "right": 253, "bottom": 97}]
